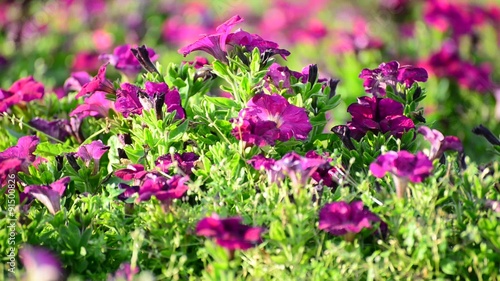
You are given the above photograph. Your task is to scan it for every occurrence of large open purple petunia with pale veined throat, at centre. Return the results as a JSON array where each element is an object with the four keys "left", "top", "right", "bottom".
[{"left": 231, "top": 94, "right": 312, "bottom": 146}]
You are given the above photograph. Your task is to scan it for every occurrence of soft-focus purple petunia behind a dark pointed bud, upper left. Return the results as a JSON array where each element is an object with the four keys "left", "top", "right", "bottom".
[{"left": 99, "top": 44, "right": 158, "bottom": 77}]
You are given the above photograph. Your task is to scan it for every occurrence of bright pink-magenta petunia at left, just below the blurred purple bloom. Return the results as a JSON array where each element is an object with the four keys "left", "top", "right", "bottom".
[{"left": 69, "top": 91, "right": 115, "bottom": 120}]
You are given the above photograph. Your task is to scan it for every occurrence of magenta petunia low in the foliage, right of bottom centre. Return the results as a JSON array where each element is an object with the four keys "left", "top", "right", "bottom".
[{"left": 319, "top": 201, "right": 380, "bottom": 241}]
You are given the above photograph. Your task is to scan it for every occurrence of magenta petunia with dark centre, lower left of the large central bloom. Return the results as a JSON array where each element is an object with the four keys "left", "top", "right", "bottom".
[{"left": 137, "top": 173, "right": 189, "bottom": 202}]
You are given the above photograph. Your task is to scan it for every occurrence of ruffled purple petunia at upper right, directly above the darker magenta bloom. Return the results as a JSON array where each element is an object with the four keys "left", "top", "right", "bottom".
[{"left": 359, "top": 61, "right": 428, "bottom": 97}]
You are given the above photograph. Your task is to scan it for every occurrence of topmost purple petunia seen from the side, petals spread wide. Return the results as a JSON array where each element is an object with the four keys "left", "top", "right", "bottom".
[{"left": 179, "top": 15, "right": 290, "bottom": 62}]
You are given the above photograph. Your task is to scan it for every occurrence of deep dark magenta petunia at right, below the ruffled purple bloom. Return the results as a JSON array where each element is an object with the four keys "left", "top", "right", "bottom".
[{"left": 347, "top": 97, "right": 415, "bottom": 140}]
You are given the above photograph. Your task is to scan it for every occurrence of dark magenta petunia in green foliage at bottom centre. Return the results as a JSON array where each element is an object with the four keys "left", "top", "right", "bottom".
[{"left": 196, "top": 214, "right": 264, "bottom": 251}]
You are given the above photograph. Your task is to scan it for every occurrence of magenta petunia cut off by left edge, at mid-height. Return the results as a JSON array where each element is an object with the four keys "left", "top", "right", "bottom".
[{"left": 0, "top": 136, "right": 44, "bottom": 186}]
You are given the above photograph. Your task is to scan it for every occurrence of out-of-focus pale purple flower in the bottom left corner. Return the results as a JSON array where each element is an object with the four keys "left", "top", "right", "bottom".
[{"left": 19, "top": 245, "right": 63, "bottom": 280}]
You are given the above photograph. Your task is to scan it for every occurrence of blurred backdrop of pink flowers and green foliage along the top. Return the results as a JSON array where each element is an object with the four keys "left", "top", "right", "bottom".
[{"left": 0, "top": 0, "right": 500, "bottom": 163}]
